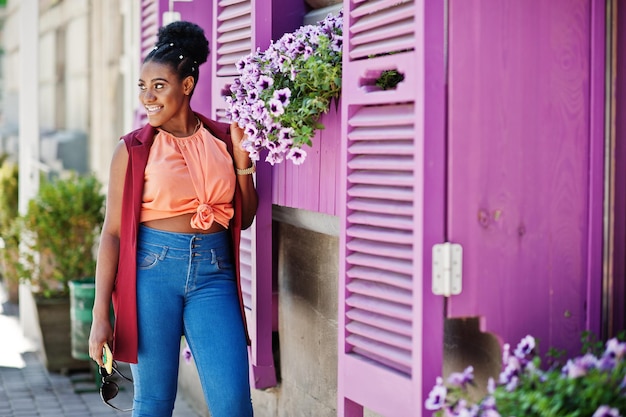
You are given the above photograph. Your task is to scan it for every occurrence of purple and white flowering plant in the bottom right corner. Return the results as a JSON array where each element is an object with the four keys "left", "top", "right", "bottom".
[{"left": 425, "top": 335, "right": 626, "bottom": 417}]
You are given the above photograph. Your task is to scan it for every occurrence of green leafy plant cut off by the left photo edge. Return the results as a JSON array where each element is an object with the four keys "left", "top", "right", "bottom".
[{"left": 0, "top": 156, "right": 20, "bottom": 303}]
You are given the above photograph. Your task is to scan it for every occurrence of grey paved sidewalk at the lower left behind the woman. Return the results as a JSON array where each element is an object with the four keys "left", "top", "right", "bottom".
[{"left": 0, "top": 283, "right": 200, "bottom": 417}]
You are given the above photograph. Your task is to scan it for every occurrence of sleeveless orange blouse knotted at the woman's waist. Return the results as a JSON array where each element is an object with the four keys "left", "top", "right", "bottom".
[{"left": 140, "top": 126, "right": 236, "bottom": 230}]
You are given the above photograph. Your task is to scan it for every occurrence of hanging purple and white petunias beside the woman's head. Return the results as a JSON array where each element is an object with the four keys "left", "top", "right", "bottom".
[{"left": 224, "top": 12, "right": 343, "bottom": 165}]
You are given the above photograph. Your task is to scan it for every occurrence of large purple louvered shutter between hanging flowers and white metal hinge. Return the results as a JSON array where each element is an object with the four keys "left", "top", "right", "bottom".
[{"left": 338, "top": 0, "right": 445, "bottom": 417}]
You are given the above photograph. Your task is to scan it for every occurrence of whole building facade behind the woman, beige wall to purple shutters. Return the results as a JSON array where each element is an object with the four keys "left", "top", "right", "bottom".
[{"left": 3, "top": 0, "right": 626, "bottom": 417}]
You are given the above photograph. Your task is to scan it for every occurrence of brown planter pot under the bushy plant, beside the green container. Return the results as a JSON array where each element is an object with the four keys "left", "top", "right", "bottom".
[{"left": 34, "top": 296, "right": 89, "bottom": 373}]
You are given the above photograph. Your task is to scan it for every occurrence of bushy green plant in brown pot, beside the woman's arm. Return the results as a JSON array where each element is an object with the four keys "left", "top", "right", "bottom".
[{"left": 21, "top": 173, "right": 104, "bottom": 371}]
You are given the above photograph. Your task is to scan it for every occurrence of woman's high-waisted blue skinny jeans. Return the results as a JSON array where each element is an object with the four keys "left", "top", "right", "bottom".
[{"left": 131, "top": 226, "right": 253, "bottom": 417}]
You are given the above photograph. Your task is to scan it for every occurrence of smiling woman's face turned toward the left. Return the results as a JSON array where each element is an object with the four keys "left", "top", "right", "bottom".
[{"left": 139, "top": 62, "right": 193, "bottom": 130}]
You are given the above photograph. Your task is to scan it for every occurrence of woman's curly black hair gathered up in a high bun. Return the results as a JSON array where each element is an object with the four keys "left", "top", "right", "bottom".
[{"left": 143, "top": 21, "right": 209, "bottom": 95}]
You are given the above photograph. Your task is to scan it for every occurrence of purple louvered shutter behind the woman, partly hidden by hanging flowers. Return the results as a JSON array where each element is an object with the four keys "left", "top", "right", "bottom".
[{"left": 211, "top": 0, "right": 276, "bottom": 388}]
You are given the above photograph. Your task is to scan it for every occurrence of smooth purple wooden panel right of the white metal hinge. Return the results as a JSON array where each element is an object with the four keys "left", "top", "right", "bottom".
[{"left": 448, "top": 0, "right": 602, "bottom": 353}]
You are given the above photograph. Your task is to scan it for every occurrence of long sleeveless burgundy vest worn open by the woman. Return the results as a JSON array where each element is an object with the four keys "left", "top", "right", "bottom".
[{"left": 112, "top": 113, "right": 250, "bottom": 363}]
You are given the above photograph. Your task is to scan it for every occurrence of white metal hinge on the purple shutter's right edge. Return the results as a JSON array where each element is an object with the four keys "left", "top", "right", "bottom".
[{"left": 433, "top": 242, "right": 463, "bottom": 297}]
